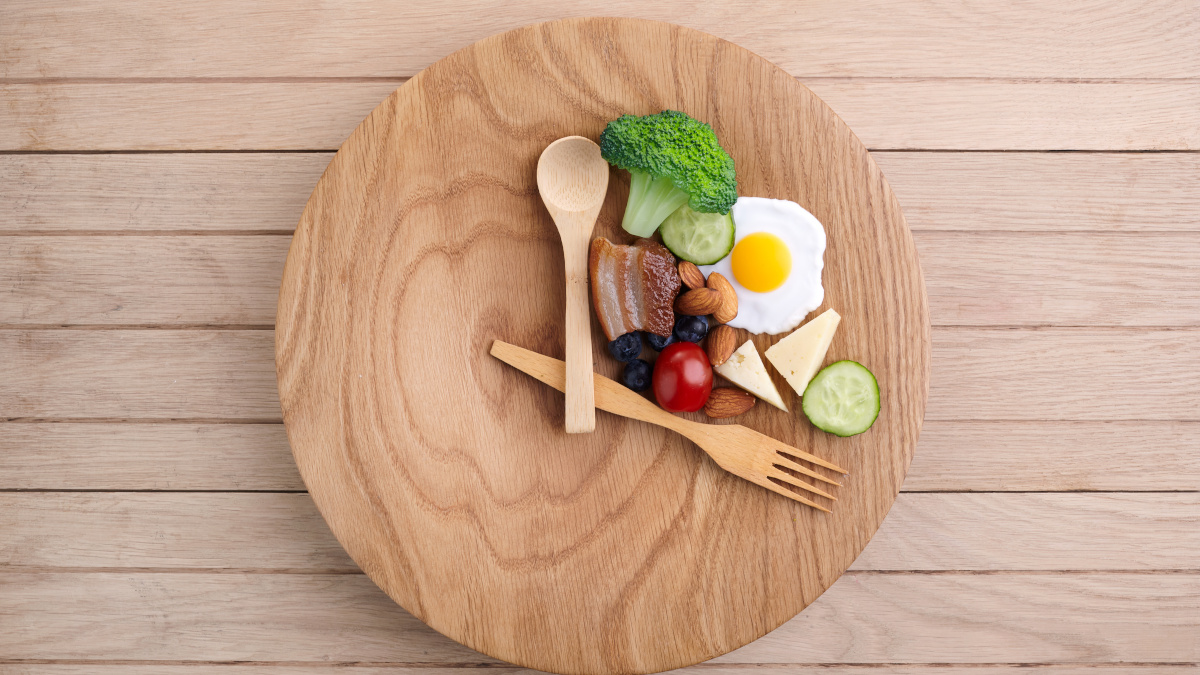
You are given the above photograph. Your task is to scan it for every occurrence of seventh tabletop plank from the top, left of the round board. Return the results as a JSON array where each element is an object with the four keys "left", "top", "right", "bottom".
[{"left": 0, "top": 492, "right": 359, "bottom": 573}]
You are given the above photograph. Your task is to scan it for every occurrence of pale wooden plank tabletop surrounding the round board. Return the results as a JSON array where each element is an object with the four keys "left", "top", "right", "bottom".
[{"left": 0, "top": 0, "right": 1200, "bottom": 675}]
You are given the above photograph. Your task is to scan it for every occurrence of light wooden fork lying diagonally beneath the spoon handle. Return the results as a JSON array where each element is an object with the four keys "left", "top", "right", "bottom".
[{"left": 492, "top": 340, "right": 846, "bottom": 513}]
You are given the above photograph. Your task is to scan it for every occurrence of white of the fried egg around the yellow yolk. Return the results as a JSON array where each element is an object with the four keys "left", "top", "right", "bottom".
[{"left": 700, "top": 197, "right": 826, "bottom": 335}]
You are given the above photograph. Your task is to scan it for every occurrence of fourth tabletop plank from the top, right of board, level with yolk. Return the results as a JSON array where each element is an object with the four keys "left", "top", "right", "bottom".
[{"left": 916, "top": 232, "right": 1200, "bottom": 327}]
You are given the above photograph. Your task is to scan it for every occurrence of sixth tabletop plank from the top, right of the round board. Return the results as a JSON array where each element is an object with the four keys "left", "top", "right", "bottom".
[{"left": 904, "top": 420, "right": 1200, "bottom": 491}]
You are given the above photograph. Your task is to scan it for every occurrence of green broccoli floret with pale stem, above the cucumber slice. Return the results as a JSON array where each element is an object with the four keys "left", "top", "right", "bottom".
[{"left": 600, "top": 110, "right": 738, "bottom": 237}]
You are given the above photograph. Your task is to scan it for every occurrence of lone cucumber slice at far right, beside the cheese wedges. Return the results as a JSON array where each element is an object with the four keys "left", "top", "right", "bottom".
[{"left": 800, "top": 362, "right": 880, "bottom": 436}]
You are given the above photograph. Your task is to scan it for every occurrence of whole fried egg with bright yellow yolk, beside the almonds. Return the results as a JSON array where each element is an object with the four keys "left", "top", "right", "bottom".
[{"left": 700, "top": 197, "right": 826, "bottom": 335}]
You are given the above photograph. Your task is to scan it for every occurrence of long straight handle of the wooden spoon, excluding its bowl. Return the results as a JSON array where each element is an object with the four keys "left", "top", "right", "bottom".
[{"left": 563, "top": 238, "right": 596, "bottom": 434}]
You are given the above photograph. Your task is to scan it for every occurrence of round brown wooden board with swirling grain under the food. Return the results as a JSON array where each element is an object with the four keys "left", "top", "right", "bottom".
[{"left": 276, "top": 14, "right": 930, "bottom": 673}]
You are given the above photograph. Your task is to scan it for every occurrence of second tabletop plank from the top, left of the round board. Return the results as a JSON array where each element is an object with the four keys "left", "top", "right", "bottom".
[{"left": 0, "top": 80, "right": 401, "bottom": 151}]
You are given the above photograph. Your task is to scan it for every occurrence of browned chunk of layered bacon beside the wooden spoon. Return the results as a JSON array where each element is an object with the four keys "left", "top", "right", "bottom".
[{"left": 588, "top": 237, "right": 680, "bottom": 340}]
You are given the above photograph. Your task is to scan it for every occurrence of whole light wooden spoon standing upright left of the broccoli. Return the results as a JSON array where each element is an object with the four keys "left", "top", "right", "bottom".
[{"left": 538, "top": 136, "right": 608, "bottom": 434}]
